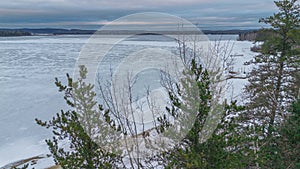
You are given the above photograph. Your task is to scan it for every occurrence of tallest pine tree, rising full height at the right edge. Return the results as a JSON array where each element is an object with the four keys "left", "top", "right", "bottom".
[{"left": 241, "top": 0, "right": 300, "bottom": 168}]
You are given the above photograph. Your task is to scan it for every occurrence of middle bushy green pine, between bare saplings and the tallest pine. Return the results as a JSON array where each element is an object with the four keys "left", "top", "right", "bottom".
[{"left": 155, "top": 59, "right": 246, "bottom": 168}]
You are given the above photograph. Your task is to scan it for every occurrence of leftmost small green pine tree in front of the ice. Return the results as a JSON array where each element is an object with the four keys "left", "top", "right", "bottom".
[{"left": 36, "top": 66, "right": 124, "bottom": 169}]
